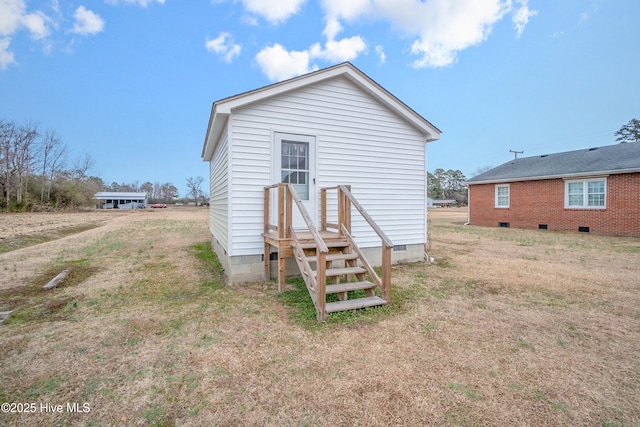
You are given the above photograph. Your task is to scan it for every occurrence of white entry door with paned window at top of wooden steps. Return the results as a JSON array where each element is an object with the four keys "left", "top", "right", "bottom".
[{"left": 274, "top": 133, "right": 317, "bottom": 230}]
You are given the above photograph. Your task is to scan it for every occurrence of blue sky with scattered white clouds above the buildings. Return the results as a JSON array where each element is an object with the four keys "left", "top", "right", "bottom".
[{"left": 0, "top": 0, "right": 640, "bottom": 196}]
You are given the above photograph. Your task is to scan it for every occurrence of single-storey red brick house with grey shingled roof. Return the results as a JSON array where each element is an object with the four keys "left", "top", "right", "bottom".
[{"left": 467, "top": 143, "right": 640, "bottom": 236}]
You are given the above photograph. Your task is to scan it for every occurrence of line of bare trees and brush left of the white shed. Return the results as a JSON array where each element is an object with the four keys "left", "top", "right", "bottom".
[{"left": 0, "top": 119, "right": 206, "bottom": 212}]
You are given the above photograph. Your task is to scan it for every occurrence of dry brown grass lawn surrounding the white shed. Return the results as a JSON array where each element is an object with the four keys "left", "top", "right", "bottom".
[{"left": 0, "top": 208, "right": 640, "bottom": 426}]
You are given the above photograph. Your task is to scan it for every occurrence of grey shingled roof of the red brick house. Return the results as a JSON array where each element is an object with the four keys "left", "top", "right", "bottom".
[{"left": 467, "top": 143, "right": 640, "bottom": 184}]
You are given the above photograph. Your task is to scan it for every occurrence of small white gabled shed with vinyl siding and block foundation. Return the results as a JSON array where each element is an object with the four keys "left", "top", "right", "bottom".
[{"left": 202, "top": 62, "right": 440, "bottom": 320}]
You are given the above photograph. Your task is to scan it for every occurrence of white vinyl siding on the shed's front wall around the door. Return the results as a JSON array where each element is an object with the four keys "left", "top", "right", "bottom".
[{"left": 230, "top": 77, "right": 426, "bottom": 256}]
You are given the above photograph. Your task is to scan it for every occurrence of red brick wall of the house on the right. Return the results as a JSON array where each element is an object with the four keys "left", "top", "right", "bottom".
[{"left": 469, "top": 173, "right": 640, "bottom": 236}]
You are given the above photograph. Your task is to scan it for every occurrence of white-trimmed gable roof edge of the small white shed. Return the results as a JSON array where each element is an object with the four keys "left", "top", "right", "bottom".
[{"left": 202, "top": 62, "right": 442, "bottom": 160}]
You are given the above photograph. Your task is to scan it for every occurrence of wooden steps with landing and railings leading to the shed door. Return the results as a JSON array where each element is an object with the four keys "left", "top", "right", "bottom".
[{"left": 262, "top": 183, "right": 394, "bottom": 321}]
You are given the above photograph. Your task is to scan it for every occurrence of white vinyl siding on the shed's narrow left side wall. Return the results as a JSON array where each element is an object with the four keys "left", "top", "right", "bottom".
[{"left": 209, "top": 129, "right": 229, "bottom": 251}]
